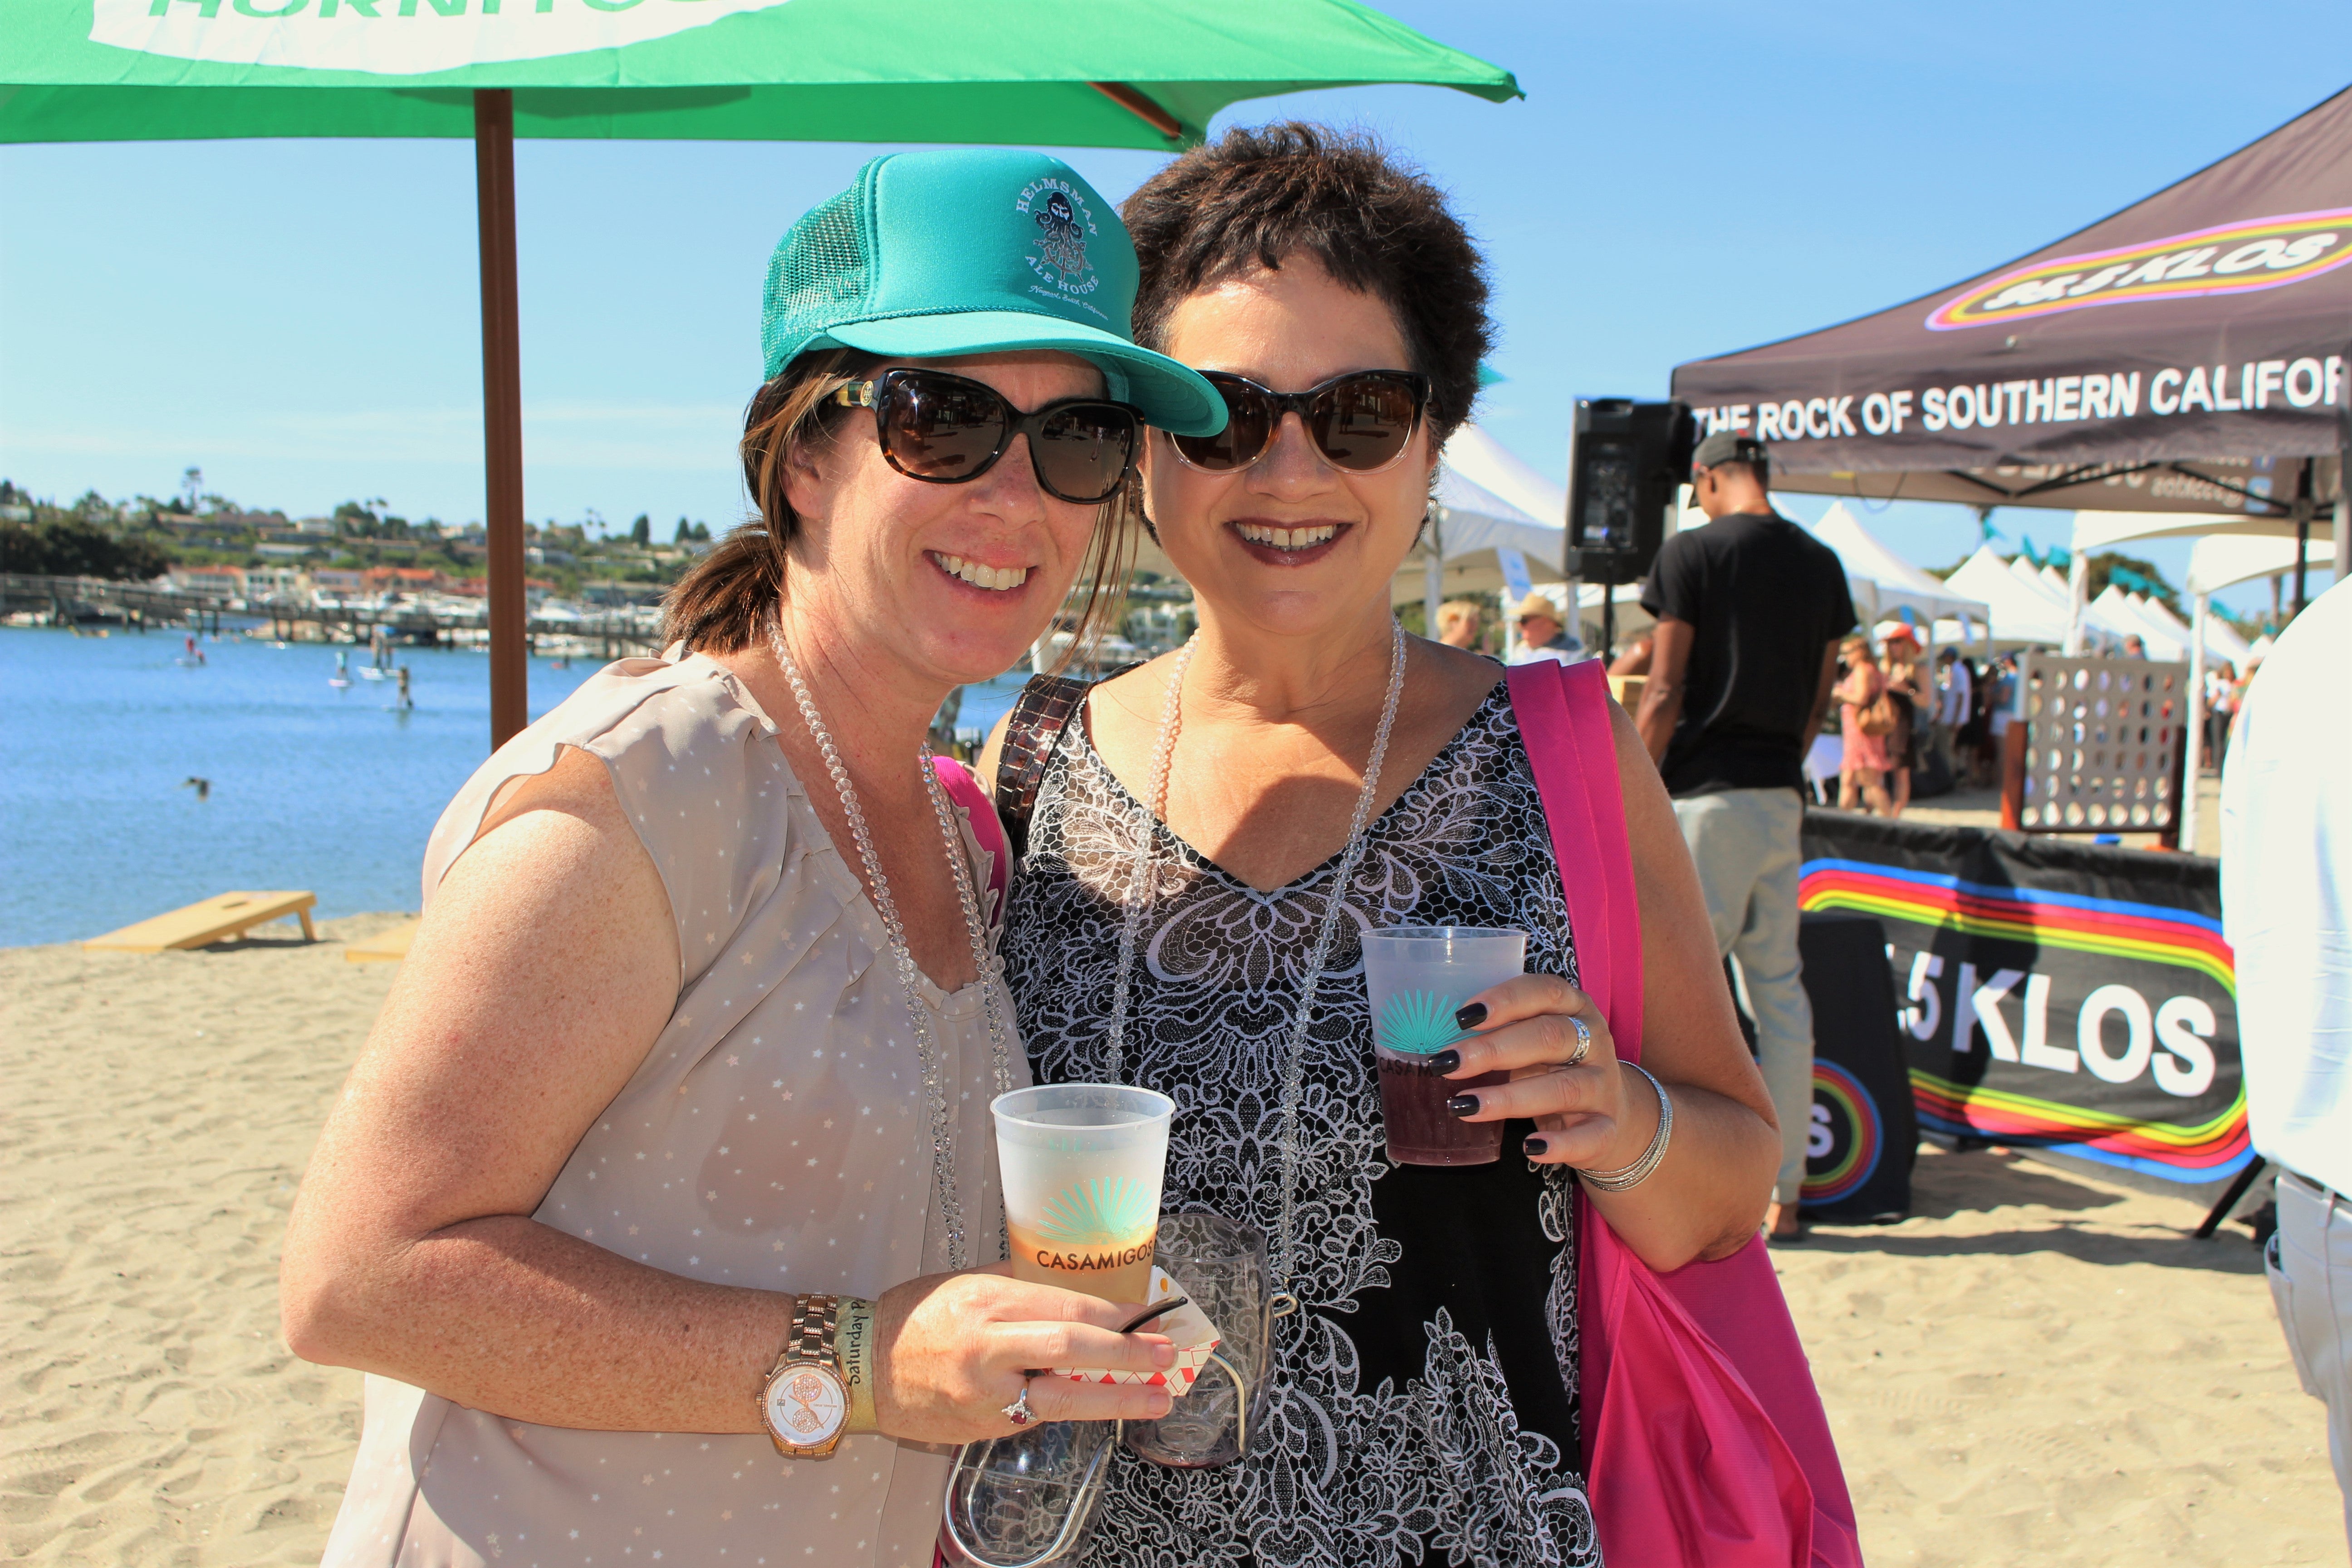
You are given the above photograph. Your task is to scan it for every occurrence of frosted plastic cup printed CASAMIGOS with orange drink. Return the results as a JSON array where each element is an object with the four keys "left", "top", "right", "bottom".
[{"left": 990, "top": 1084, "right": 1176, "bottom": 1303}]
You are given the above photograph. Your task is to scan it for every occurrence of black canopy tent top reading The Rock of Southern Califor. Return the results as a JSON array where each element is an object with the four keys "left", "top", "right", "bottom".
[{"left": 1675, "top": 89, "right": 2352, "bottom": 543}]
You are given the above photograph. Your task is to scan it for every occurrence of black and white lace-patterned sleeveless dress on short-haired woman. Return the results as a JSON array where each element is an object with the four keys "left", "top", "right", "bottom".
[{"left": 1004, "top": 684, "right": 1599, "bottom": 1568}]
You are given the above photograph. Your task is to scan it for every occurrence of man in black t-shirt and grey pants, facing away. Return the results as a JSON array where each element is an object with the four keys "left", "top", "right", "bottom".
[{"left": 1635, "top": 432, "right": 1853, "bottom": 1239}]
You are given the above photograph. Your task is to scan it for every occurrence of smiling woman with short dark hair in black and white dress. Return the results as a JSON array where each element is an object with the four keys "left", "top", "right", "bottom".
[{"left": 983, "top": 125, "right": 1780, "bottom": 1566}]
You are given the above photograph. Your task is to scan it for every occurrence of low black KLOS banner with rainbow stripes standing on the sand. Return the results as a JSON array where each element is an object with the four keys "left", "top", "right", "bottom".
[{"left": 1799, "top": 813, "right": 2251, "bottom": 1185}]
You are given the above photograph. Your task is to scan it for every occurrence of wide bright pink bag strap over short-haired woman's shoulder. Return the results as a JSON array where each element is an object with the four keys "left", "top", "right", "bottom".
[{"left": 1505, "top": 658, "right": 1642, "bottom": 1063}]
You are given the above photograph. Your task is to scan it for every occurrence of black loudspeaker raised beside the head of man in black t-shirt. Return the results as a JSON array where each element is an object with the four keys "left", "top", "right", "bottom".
[{"left": 1562, "top": 397, "right": 1698, "bottom": 585}]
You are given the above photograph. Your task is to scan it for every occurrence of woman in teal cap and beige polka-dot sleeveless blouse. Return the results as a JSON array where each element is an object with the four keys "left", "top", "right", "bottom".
[{"left": 282, "top": 151, "right": 1223, "bottom": 1568}]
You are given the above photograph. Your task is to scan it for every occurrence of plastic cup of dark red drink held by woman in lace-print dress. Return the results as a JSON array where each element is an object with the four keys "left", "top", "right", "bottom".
[{"left": 1364, "top": 926, "right": 1526, "bottom": 1166}]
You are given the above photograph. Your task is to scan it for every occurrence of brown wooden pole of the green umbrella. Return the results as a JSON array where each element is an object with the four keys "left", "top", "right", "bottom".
[{"left": 473, "top": 87, "right": 529, "bottom": 750}]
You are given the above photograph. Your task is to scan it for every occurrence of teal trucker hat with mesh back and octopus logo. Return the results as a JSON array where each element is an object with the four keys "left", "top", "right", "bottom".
[{"left": 760, "top": 148, "right": 1225, "bottom": 435}]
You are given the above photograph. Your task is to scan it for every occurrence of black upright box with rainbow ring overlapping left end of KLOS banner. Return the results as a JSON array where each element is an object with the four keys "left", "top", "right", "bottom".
[{"left": 1797, "top": 912, "right": 1919, "bottom": 1225}]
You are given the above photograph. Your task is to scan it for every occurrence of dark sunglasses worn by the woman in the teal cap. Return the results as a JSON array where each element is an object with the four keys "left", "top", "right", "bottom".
[{"left": 833, "top": 369, "right": 1143, "bottom": 505}]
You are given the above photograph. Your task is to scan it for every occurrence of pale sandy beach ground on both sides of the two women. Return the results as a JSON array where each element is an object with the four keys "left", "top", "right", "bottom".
[{"left": 0, "top": 915, "right": 2347, "bottom": 1568}]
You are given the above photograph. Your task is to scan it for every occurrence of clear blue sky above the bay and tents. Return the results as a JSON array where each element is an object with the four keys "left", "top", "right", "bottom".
[{"left": 0, "top": 0, "right": 2352, "bottom": 607}]
